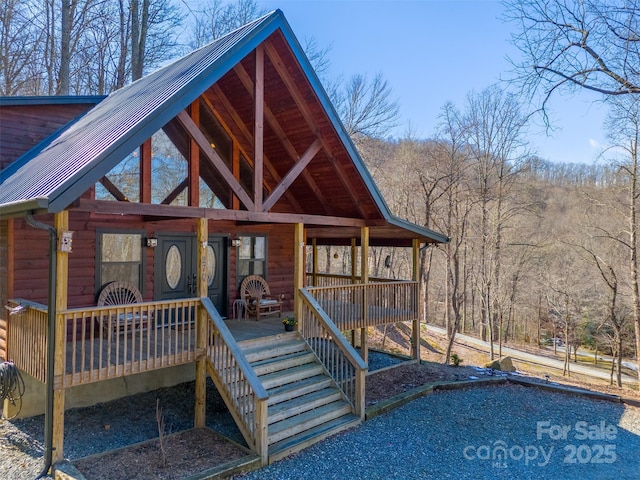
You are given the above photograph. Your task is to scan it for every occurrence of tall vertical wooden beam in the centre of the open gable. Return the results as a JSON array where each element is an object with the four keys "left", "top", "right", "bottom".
[{"left": 253, "top": 45, "right": 264, "bottom": 212}]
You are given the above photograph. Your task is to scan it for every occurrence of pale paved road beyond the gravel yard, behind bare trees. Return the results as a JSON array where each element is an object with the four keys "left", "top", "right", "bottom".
[{"left": 426, "top": 325, "right": 638, "bottom": 383}]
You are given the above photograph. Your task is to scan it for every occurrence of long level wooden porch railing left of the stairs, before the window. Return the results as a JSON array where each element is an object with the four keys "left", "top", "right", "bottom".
[{"left": 59, "top": 299, "right": 204, "bottom": 388}]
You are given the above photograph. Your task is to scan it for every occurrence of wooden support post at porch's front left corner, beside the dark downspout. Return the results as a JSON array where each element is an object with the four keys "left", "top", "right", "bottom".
[{"left": 52, "top": 210, "right": 69, "bottom": 463}]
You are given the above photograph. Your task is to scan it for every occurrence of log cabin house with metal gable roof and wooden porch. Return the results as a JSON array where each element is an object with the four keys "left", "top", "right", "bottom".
[{"left": 0, "top": 11, "right": 448, "bottom": 464}]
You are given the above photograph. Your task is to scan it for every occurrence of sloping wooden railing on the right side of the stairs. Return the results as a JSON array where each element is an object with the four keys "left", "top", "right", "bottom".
[{"left": 300, "top": 288, "right": 367, "bottom": 419}]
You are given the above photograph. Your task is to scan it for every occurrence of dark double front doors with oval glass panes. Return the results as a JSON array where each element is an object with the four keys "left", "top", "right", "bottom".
[{"left": 154, "top": 234, "right": 227, "bottom": 316}]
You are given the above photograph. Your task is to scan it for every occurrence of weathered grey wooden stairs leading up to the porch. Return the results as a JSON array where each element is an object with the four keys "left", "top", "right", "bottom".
[{"left": 238, "top": 332, "right": 360, "bottom": 463}]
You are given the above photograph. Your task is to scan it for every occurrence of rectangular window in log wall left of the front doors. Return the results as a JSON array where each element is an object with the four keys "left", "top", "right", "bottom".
[{"left": 96, "top": 232, "right": 143, "bottom": 291}]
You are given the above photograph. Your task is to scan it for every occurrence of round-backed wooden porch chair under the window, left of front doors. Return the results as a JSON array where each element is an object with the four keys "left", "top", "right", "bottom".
[{"left": 98, "top": 282, "right": 148, "bottom": 335}]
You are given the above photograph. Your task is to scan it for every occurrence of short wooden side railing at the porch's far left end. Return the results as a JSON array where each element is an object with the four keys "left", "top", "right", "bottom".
[{"left": 7, "top": 299, "right": 47, "bottom": 383}]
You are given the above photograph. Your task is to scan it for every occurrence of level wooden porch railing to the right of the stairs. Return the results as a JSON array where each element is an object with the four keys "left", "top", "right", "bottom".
[{"left": 307, "top": 281, "right": 418, "bottom": 331}]
